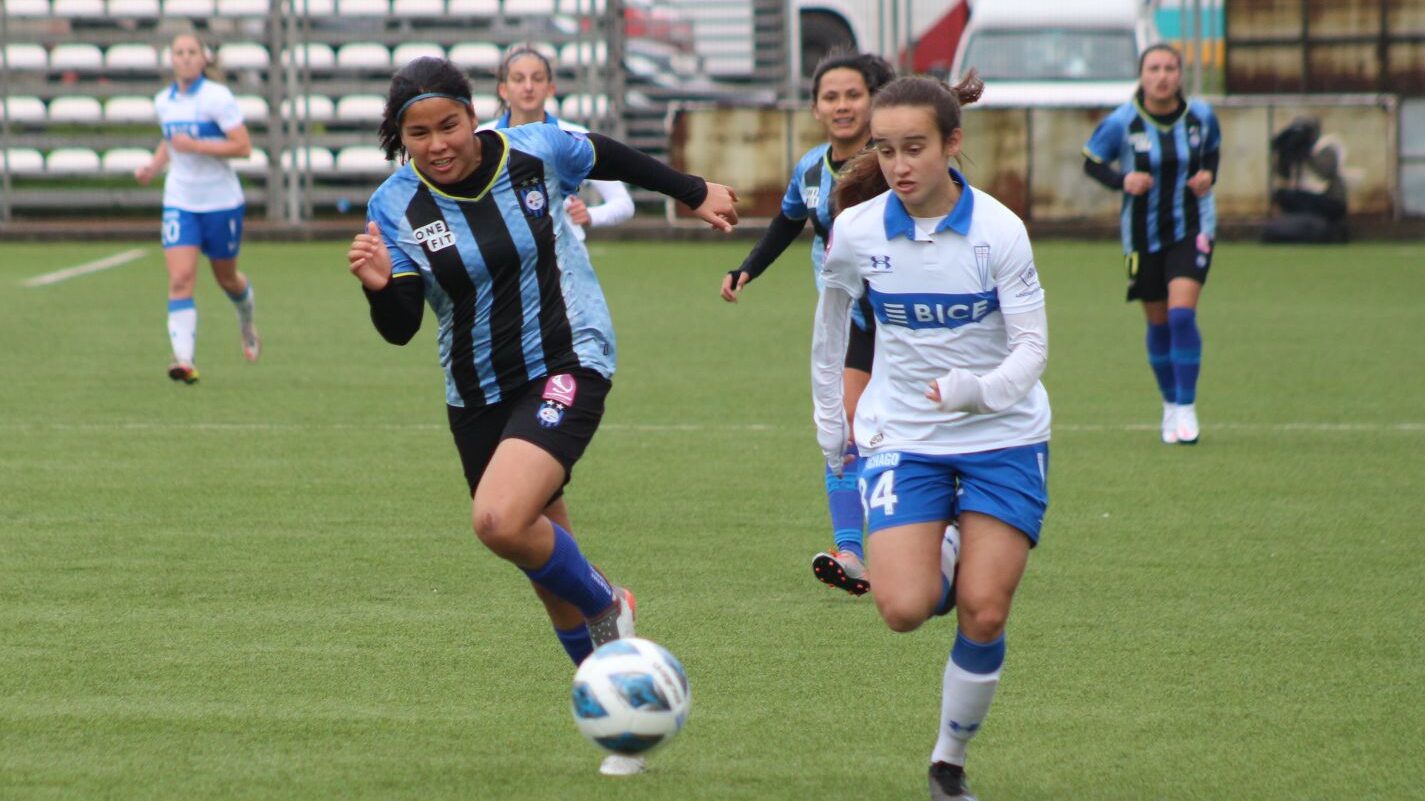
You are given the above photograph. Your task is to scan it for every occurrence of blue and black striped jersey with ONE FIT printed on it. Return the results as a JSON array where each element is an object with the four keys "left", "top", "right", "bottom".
[{"left": 368, "top": 124, "right": 616, "bottom": 408}]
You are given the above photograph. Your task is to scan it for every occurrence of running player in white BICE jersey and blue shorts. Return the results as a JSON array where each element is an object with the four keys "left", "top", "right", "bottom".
[{"left": 812, "top": 74, "right": 1049, "bottom": 801}]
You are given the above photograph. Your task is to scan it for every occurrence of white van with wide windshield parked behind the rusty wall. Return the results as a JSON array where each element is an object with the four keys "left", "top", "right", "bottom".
[{"left": 950, "top": 0, "right": 1157, "bottom": 107}]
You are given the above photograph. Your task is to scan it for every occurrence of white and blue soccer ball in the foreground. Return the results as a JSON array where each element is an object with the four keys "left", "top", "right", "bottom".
[{"left": 573, "top": 637, "right": 693, "bottom": 755}]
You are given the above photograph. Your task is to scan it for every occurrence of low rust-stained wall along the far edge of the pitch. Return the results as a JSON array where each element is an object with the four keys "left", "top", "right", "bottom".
[{"left": 673, "top": 97, "right": 1401, "bottom": 225}]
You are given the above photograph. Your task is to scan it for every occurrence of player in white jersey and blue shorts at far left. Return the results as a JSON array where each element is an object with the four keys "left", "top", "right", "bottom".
[{"left": 134, "top": 33, "right": 262, "bottom": 383}]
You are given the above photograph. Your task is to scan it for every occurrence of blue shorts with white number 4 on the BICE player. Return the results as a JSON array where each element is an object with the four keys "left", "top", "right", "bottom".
[{"left": 861, "top": 442, "right": 1049, "bottom": 546}]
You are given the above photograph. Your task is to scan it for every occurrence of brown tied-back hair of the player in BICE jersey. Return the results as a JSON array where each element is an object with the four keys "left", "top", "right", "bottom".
[{"left": 834, "top": 70, "right": 985, "bottom": 214}]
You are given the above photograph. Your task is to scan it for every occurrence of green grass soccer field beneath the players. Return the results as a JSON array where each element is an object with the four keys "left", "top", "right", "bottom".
[{"left": 0, "top": 233, "right": 1425, "bottom": 801}]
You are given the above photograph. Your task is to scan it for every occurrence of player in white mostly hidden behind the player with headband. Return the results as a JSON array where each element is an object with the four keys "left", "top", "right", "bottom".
[{"left": 480, "top": 44, "right": 633, "bottom": 241}]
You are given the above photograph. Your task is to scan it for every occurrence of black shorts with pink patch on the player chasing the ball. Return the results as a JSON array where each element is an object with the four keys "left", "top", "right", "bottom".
[{"left": 446, "top": 369, "right": 613, "bottom": 493}]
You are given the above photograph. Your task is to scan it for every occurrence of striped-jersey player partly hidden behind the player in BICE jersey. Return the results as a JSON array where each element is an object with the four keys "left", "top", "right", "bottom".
[{"left": 722, "top": 53, "right": 895, "bottom": 596}]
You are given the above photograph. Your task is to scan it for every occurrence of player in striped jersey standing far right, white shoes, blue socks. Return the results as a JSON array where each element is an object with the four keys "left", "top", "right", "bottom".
[{"left": 1083, "top": 44, "right": 1223, "bottom": 445}]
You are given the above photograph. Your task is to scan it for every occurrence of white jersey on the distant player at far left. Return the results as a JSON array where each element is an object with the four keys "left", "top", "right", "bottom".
[{"left": 154, "top": 77, "right": 242, "bottom": 211}]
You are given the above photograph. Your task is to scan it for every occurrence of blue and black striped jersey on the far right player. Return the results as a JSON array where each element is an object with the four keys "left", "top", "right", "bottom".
[{"left": 1083, "top": 98, "right": 1221, "bottom": 254}]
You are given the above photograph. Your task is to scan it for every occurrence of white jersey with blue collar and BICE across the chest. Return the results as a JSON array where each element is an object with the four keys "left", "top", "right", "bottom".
[{"left": 822, "top": 170, "right": 1049, "bottom": 455}]
